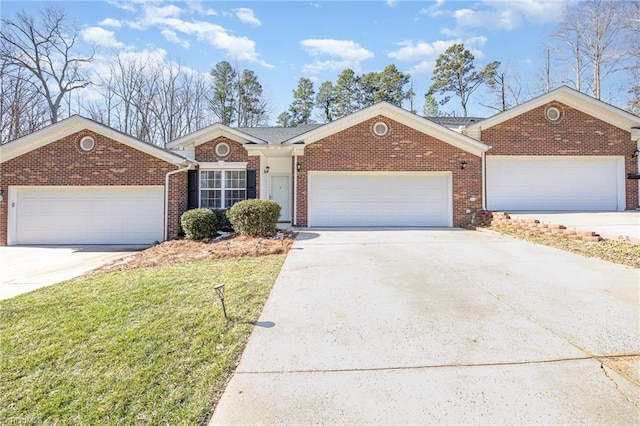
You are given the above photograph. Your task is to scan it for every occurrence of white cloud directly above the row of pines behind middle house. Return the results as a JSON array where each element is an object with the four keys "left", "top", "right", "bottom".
[{"left": 300, "top": 39, "right": 374, "bottom": 73}]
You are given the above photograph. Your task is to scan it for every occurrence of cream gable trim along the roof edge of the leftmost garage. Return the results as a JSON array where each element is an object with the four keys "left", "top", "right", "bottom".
[{"left": 0, "top": 115, "right": 191, "bottom": 164}]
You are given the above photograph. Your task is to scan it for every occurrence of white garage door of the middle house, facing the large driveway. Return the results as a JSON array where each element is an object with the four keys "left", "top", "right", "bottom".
[{"left": 308, "top": 172, "right": 452, "bottom": 226}]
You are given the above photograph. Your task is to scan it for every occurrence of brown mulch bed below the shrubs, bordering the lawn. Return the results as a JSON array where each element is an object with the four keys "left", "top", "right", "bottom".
[{"left": 89, "top": 231, "right": 297, "bottom": 274}]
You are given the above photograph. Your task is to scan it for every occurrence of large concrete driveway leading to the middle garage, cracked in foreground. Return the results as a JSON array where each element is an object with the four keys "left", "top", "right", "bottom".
[{"left": 210, "top": 229, "right": 640, "bottom": 425}]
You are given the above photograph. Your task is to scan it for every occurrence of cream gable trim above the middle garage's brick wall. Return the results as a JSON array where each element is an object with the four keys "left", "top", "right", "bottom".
[{"left": 283, "top": 102, "right": 489, "bottom": 156}]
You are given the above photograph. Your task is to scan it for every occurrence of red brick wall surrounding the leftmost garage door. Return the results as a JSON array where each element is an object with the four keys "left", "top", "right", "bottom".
[{"left": 0, "top": 130, "right": 187, "bottom": 245}]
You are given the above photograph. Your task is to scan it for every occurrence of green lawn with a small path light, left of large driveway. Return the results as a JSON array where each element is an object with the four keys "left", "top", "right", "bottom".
[{"left": 0, "top": 255, "right": 284, "bottom": 425}]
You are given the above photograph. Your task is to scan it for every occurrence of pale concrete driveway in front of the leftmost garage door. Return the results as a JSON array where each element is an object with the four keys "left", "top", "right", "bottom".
[{"left": 0, "top": 245, "right": 149, "bottom": 300}]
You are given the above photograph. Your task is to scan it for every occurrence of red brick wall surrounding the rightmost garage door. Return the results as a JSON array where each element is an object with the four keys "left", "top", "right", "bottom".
[{"left": 481, "top": 102, "right": 638, "bottom": 209}]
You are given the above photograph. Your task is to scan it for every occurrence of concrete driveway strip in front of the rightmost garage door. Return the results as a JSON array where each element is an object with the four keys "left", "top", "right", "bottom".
[{"left": 507, "top": 211, "right": 640, "bottom": 244}]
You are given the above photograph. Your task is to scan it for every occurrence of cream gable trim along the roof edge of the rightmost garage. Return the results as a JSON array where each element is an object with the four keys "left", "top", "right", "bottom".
[{"left": 467, "top": 86, "right": 640, "bottom": 136}]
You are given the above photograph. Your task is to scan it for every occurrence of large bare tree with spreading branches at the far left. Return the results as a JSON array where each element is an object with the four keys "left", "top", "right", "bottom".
[{"left": 0, "top": 7, "right": 94, "bottom": 123}]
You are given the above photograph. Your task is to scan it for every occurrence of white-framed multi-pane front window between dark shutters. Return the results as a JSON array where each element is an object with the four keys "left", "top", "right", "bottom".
[{"left": 200, "top": 170, "right": 247, "bottom": 209}]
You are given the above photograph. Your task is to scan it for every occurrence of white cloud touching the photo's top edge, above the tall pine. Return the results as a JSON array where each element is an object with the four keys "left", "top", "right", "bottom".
[{"left": 453, "top": 0, "right": 566, "bottom": 30}]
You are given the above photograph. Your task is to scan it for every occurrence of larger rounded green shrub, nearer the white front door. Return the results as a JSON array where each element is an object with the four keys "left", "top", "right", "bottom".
[{"left": 227, "top": 199, "right": 280, "bottom": 237}]
